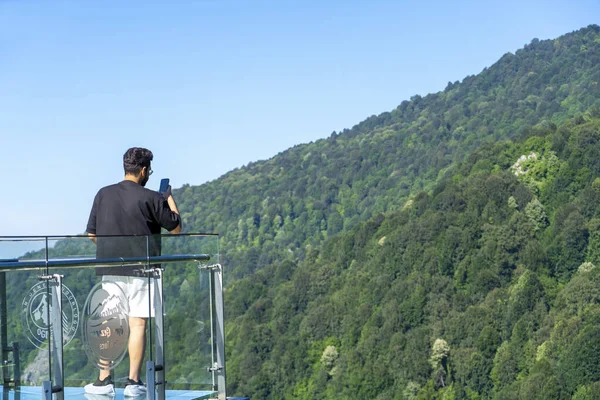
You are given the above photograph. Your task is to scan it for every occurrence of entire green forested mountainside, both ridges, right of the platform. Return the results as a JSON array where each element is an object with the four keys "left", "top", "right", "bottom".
[{"left": 165, "top": 25, "right": 600, "bottom": 399}]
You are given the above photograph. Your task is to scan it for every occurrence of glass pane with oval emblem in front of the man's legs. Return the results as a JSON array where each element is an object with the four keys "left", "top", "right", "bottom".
[{"left": 49, "top": 236, "right": 150, "bottom": 388}]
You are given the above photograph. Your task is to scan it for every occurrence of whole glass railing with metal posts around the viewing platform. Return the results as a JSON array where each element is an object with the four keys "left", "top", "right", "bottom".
[{"left": 0, "top": 234, "right": 226, "bottom": 399}]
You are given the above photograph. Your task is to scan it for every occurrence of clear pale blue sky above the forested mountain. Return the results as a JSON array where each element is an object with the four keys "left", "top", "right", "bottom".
[{"left": 0, "top": 0, "right": 600, "bottom": 242}]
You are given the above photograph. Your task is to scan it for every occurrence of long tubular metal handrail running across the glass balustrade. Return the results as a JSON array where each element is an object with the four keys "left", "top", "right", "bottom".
[{"left": 0, "top": 254, "right": 210, "bottom": 272}]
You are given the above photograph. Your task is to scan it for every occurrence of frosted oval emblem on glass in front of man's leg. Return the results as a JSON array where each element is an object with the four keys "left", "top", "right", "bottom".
[{"left": 82, "top": 282, "right": 129, "bottom": 369}]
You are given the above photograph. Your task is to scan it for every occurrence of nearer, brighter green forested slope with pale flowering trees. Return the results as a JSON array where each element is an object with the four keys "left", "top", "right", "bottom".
[{"left": 228, "top": 114, "right": 600, "bottom": 399}]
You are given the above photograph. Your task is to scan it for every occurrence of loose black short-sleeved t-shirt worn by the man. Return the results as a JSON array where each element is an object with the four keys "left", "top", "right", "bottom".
[{"left": 87, "top": 180, "right": 181, "bottom": 276}]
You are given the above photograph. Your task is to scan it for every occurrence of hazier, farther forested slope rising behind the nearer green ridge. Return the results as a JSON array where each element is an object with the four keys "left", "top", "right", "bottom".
[{"left": 176, "top": 25, "right": 600, "bottom": 279}]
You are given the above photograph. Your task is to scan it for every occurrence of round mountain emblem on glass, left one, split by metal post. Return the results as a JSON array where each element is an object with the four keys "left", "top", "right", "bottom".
[{"left": 21, "top": 282, "right": 79, "bottom": 349}]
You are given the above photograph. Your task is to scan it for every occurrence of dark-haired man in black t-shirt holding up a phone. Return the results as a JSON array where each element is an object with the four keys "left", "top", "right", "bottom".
[{"left": 85, "top": 147, "right": 181, "bottom": 396}]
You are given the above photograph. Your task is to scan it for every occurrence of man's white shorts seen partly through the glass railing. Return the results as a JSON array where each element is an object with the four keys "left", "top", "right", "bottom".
[{"left": 102, "top": 275, "right": 154, "bottom": 318}]
